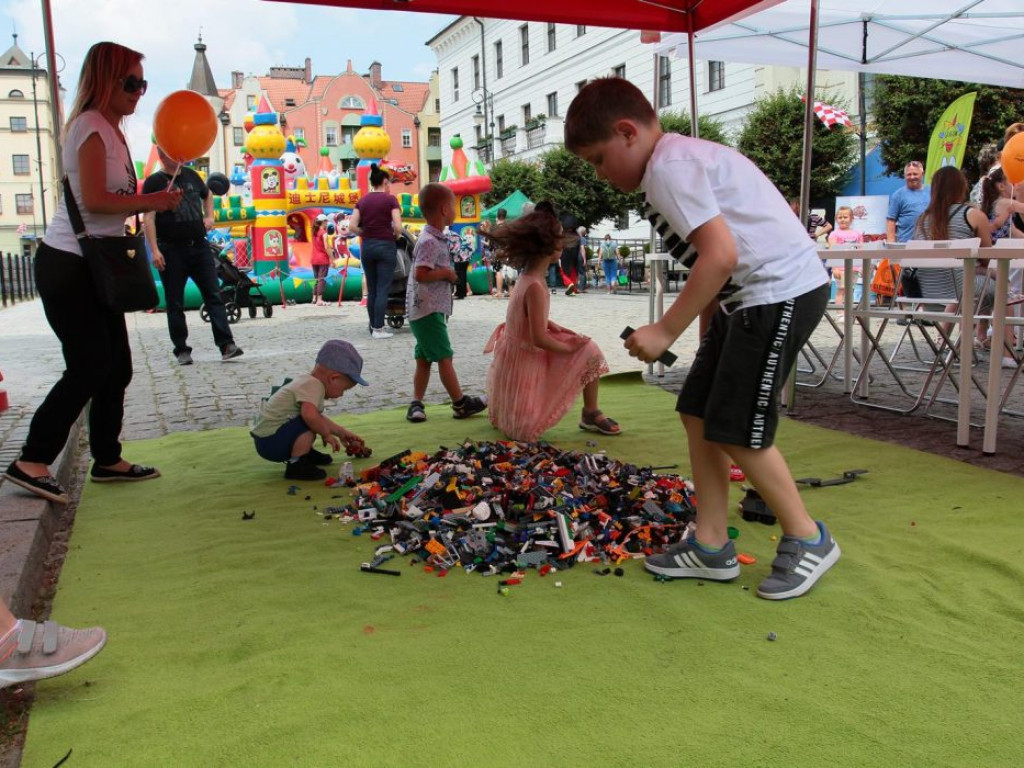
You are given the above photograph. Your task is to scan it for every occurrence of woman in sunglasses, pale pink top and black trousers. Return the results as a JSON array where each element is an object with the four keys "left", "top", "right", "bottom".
[{"left": 4, "top": 43, "right": 181, "bottom": 504}]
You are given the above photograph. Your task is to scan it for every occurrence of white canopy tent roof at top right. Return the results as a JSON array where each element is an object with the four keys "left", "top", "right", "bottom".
[{"left": 660, "top": 0, "right": 1024, "bottom": 88}]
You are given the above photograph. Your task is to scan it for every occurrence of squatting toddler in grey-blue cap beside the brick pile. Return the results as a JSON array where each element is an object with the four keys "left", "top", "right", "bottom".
[{"left": 250, "top": 339, "right": 372, "bottom": 480}]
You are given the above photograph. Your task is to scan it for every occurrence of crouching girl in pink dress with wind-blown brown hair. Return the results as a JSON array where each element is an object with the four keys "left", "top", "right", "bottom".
[{"left": 483, "top": 210, "right": 622, "bottom": 441}]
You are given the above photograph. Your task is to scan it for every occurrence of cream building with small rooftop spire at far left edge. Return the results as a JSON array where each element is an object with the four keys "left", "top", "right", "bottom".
[{"left": 0, "top": 35, "right": 60, "bottom": 253}]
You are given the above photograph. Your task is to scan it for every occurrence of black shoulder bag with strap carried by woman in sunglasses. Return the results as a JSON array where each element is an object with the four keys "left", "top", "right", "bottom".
[{"left": 63, "top": 176, "right": 160, "bottom": 312}]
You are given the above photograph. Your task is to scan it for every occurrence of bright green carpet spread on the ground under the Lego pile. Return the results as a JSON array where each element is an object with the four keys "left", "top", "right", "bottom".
[{"left": 24, "top": 378, "right": 1024, "bottom": 768}]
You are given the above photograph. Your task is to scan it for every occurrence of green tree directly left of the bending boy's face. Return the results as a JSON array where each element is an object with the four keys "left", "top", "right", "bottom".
[{"left": 531, "top": 146, "right": 640, "bottom": 227}]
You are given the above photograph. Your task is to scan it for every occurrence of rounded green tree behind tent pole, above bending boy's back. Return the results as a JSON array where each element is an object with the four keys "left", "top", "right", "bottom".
[{"left": 736, "top": 88, "right": 857, "bottom": 200}]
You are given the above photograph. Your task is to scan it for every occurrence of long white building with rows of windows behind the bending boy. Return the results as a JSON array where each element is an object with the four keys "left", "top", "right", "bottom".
[{"left": 427, "top": 16, "right": 858, "bottom": 233}]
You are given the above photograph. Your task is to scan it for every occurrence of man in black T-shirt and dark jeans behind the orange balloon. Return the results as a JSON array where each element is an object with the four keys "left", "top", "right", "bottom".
[{"left": 142, "top": 147, "right": 242, "bottom": 366}]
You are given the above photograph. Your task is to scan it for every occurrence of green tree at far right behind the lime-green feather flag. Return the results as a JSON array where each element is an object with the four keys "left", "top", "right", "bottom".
[{"left": 871, "top": 75, "right": 1024, "bottom": 180}]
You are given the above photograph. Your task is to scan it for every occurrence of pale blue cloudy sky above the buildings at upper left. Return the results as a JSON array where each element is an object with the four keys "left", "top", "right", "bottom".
[{"left": 0, "top": 0, "right": 456, "bottom": 160}]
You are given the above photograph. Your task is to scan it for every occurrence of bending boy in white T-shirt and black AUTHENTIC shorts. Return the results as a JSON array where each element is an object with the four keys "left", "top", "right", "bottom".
[{"left": 565, "top": 78, "right": 840, "bottom": 600}]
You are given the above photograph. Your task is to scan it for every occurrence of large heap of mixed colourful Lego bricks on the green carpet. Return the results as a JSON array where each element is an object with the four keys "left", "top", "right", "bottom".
[{"left": 334, "top": 441, "right": 695, "bottom": 575}]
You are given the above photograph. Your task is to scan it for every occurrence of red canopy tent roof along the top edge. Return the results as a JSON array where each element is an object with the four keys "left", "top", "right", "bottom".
[{"left": 262, "top": 0, "right": 780, "bottom": 32}]
